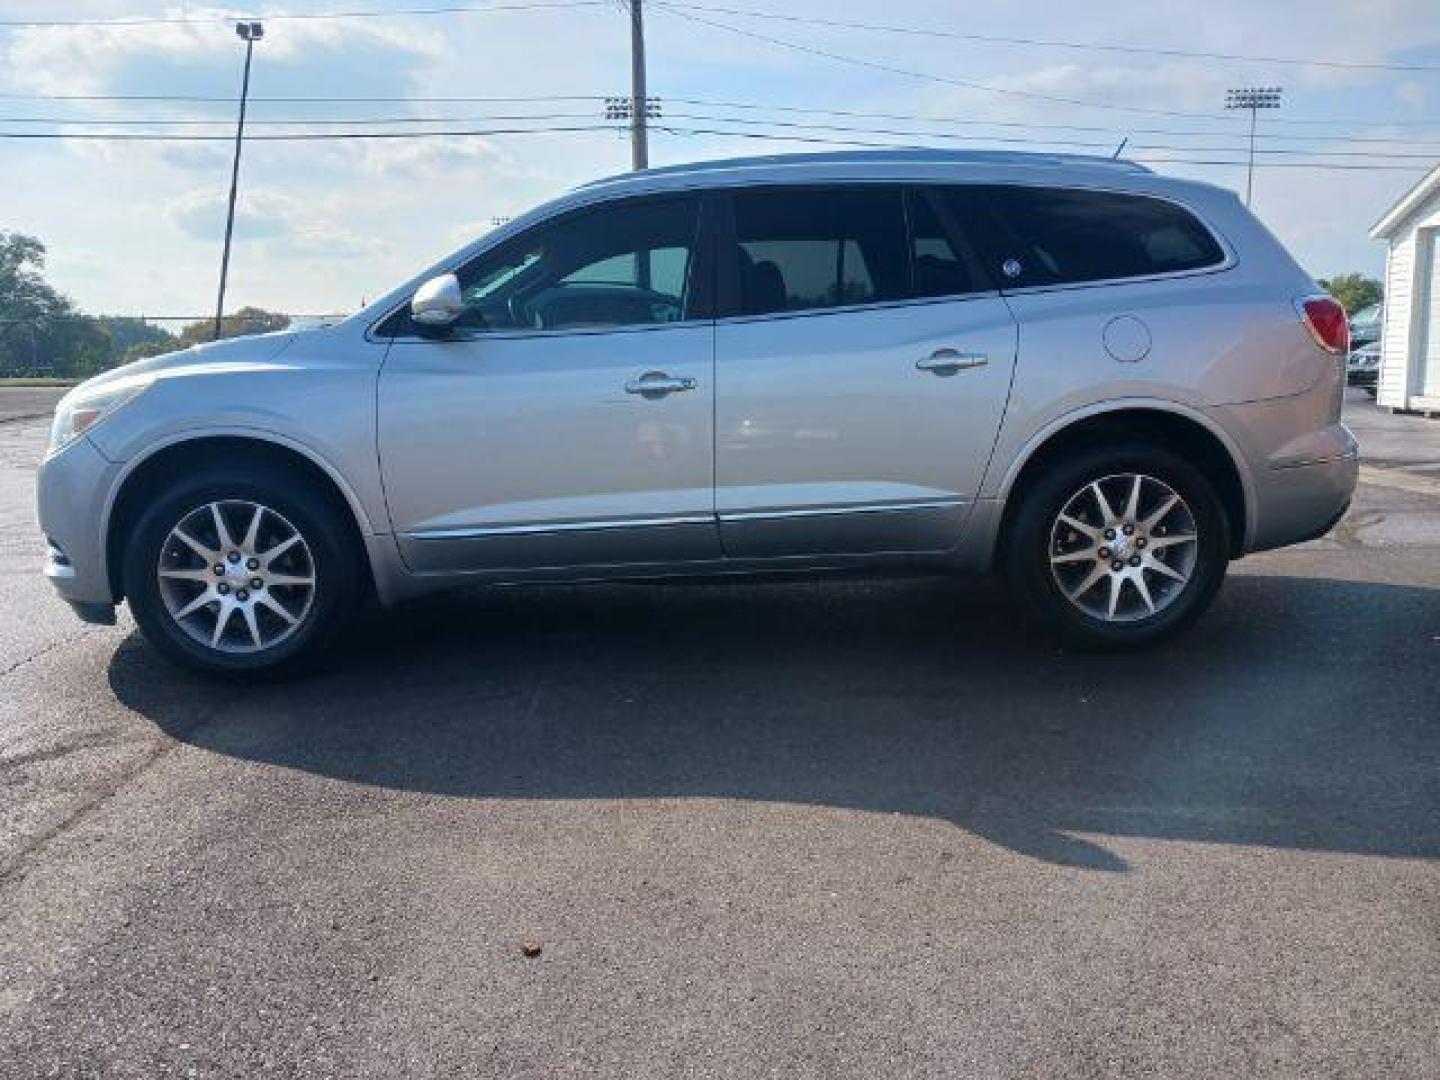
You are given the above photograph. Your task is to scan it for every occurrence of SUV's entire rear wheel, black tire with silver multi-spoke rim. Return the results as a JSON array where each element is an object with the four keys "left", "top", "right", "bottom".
[{"left": 1004, "top": 444, "right": 1230, "bottom": 648}]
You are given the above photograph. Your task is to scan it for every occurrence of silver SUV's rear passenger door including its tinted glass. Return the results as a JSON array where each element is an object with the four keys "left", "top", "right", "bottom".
[{"left": 716, "top": 184, "right": 1017, "bottom": 559}]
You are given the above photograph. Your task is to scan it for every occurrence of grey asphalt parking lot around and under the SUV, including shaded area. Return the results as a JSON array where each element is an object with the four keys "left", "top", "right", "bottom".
[{"left": 0, "top": 392, "right": 1440, "bottom": 1077}]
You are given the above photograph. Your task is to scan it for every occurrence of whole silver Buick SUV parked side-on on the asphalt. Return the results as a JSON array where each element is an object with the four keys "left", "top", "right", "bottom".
[{"left": 39, "top": 151, "right": 1356, "bottom": 672}]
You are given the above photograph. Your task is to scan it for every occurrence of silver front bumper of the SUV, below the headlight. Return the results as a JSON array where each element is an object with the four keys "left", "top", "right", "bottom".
[{"left": 36, "top": 438, "right": 120, "bottom": 622}]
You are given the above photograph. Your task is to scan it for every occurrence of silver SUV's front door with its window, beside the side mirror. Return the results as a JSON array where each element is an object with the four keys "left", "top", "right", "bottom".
[{"left": 379, "top": 197, "right": 720, "bottom": 573}]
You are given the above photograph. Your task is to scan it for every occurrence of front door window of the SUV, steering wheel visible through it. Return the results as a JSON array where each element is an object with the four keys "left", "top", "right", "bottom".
[{"left": 420, "top": 199, "right": 700, "bottom": 330}]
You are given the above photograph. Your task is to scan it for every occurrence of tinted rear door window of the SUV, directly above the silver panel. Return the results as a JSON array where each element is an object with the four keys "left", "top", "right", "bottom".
[{"left": 732, "top": 187, "right": 909, "bottom": 315}]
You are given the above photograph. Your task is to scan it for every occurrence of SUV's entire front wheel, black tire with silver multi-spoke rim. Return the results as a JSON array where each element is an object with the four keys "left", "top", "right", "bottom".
[{"left": 124, "top": 465, "right": 361, "bottom": 674}]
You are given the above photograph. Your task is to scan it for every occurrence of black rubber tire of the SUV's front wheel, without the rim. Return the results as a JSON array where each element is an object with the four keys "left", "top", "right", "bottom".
[{"left": 122, "top": 462, "right": 364, "bottom": 677}]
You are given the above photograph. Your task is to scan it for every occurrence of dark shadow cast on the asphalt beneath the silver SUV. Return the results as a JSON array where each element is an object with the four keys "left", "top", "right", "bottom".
[{"left": 109, "top": 576, "right": 1440, "bottom": 871}]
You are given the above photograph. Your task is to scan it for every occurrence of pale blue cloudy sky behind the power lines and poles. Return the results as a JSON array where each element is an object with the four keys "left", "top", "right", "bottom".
[{"left": 0, "top": 0, "right": 1440, "bottom": 315}]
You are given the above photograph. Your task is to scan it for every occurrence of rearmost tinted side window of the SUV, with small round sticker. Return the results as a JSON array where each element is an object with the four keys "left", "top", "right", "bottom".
[{"left": 945, "top": 187, "right": 1224, "bottom": 285}]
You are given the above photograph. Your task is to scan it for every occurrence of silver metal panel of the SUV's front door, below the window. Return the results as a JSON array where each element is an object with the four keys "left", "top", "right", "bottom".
[{"left": 379, "top": 321, "right": 720, "bottom": 573}]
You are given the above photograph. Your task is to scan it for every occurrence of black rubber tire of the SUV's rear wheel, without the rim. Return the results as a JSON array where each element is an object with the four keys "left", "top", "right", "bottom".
[{"left": 1001, "top": 442, "right": 1230, "bottom": 649}]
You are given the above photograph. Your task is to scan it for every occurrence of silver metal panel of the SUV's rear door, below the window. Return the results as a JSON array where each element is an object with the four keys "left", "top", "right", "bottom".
[{"left": 716, "top": 294, "right": 1015, "bottom": 557}]
